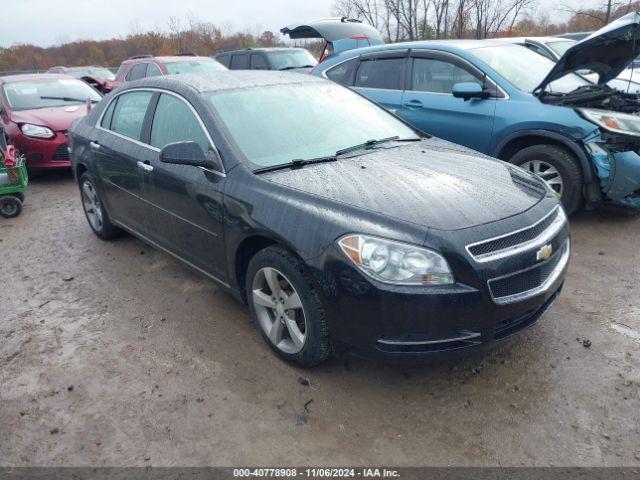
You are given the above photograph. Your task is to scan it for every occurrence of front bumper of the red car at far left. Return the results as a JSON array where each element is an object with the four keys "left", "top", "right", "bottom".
[{"left": 10, "top": 132, "right": 71, "bottom": 170}]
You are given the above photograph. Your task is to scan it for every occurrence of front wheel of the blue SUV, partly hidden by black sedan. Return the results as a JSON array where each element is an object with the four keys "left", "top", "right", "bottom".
[{"left": 509, "top": 145, "right": 583, "bottom": 214}]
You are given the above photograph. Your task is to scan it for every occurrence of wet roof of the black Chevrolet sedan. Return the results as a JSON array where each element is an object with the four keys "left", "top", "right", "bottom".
[{"left": 119, "top": 70, "right": 328, "bottom": 93}]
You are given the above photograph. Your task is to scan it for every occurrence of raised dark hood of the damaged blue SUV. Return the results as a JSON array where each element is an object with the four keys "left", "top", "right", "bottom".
[{"left": 535, "top": 12, "right": 640, "bottom": 92}]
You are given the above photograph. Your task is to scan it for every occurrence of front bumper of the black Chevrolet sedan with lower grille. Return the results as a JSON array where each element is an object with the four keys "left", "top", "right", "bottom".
[{"left": 312, "top": 202, "right": 570, "bottom": 361}]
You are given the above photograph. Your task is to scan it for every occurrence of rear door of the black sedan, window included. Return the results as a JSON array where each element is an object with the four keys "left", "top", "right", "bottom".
[{"left": 90, "top": 91, "right": 154, "bottom": 235}]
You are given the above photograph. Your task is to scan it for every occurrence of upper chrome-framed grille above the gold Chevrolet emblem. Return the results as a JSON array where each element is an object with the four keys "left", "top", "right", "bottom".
[{"left": 467, "top": 207, "right": 566, "bottom": 262}]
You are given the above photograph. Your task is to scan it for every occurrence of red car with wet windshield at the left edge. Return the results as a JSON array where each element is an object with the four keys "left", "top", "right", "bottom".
[{"left": 0, "top": 74, "right": 102, "bottom": 169}]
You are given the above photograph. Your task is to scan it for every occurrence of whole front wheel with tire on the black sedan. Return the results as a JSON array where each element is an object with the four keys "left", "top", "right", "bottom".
[{"left": 245, "top": 246, "right": 331, "bottom": 368}]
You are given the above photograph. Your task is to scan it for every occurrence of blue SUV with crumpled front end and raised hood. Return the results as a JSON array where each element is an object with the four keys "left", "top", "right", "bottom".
[{"left": 294, "top": 13, "right": 640, "bottom": 213}]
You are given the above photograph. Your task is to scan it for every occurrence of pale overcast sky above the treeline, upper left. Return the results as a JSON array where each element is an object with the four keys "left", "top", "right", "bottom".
[{"left": 0, "top": 0, "right": 334, "bottom": 47}]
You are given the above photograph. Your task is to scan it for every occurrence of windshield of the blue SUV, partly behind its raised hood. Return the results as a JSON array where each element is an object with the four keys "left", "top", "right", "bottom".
[{"left": 472, "top": 45, "right": 591, "bottom": 93}]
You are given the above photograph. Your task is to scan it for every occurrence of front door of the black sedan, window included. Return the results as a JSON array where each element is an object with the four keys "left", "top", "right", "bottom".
[{"left": 144, "top": 92, "right": 227, "bottom": 281}]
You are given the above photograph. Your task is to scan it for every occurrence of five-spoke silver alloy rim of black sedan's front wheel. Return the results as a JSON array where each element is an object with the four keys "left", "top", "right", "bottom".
[{"left": 251, "top": 267, "right": 307, "bottom": 354}]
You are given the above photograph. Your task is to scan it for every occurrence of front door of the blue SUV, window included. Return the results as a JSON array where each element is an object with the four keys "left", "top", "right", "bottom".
[{"left": 401, "top": 50, "right": 500, "bottom": 153}]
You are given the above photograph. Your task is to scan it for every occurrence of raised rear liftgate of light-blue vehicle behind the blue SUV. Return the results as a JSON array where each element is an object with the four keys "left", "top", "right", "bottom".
[{"left": 280, "top": 17, "right": 384, "bottom": 53}]
